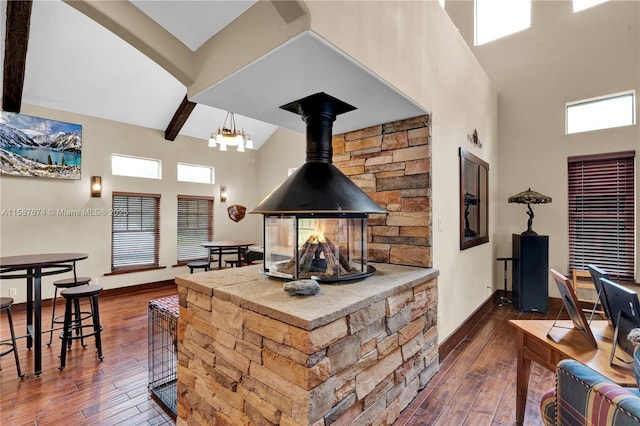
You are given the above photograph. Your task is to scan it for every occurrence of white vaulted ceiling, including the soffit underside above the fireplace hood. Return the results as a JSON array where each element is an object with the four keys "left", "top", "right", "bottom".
[{"left": 0, "top": 0, "right": 424, "bottom": 148}]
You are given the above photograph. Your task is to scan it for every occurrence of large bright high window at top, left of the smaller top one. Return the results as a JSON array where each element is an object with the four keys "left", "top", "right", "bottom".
[{"left": 475, "top": 0, "right": 531, "bottom": 46}]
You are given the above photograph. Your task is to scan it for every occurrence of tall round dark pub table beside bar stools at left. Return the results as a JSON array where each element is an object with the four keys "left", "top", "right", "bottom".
[{"left": 0, "top": 253, "right": 89, "bottom": 376}]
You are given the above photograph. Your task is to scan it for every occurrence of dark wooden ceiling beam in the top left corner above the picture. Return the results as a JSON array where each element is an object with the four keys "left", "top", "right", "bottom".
[{"left": 2, "top": 0, "right": 33, "bottom": 112}]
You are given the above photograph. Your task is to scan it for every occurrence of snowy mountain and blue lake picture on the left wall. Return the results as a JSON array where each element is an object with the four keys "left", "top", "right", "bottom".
[{"left": 0, "top": 111, "right": 82, "bottom": 179}]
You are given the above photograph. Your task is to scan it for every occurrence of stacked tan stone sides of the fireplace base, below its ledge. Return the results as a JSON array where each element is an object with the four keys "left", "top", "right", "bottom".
[{"left": 177, "top": 278, "right": 438, "bottom": 426}]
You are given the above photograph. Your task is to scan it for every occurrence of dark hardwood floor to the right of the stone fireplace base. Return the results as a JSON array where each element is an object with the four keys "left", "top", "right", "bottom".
[{"left": 395, "top": 304, "right": 557, "bottom": 426}]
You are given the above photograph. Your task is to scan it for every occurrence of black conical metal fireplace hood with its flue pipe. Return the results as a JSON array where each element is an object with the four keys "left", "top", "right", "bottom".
[{"left": 251, "top": 92, "right": 387, "bottom": 214}]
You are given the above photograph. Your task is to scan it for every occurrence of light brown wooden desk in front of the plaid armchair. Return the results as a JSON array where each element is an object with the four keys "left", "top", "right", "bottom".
[{"left": 509, "top": 320, "right": 636, "bottom": 424}]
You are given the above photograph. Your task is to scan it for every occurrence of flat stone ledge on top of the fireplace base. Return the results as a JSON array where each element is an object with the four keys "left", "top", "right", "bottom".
[{"left": 175, "top": 263, "right": 439, "bottom": 330}]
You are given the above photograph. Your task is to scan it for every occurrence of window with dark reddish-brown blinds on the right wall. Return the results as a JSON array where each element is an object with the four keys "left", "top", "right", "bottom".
[{"left": 568, "top": 151, "right": 635, "bottom": 280}]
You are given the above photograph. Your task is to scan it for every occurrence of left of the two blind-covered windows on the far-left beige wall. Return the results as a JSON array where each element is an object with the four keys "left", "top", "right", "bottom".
[{"left": 111, "top": 192, "right": 160, "bottom": 271}]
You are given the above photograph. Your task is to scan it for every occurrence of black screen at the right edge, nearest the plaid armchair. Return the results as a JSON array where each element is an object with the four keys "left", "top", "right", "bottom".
[{"left": 600, "top": 278, "right": 640, "bottom": 355}]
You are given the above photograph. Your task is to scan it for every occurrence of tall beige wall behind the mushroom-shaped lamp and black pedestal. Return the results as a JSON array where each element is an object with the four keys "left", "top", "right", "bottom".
[{"left": 447, "top": 0, "right": 640, "bottom": 297}]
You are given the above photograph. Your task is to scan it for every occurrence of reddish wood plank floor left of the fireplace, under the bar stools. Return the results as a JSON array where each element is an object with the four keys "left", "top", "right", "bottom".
[{"left": 0, "top": 285, "right": 176, "bottom": 426}]
